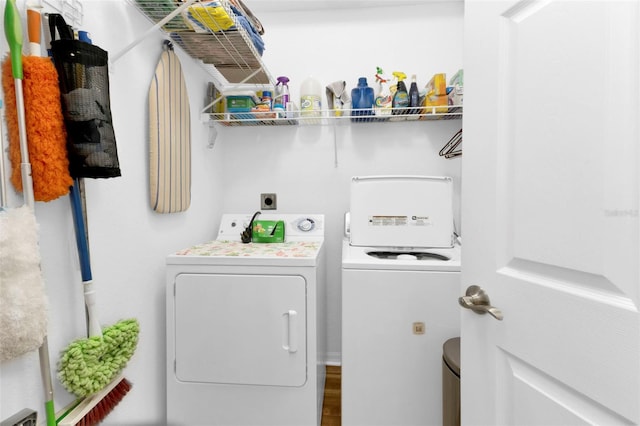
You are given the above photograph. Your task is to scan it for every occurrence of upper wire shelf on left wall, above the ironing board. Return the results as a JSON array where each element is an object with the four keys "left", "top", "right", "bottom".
[{"left": 128, "top": 0, "right": 275, "bottom": 90}]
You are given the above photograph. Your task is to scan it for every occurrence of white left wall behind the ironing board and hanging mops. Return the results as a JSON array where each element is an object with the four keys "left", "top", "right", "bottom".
[{"left": 0, "top": 0, "right": 224, "bottom": 424}]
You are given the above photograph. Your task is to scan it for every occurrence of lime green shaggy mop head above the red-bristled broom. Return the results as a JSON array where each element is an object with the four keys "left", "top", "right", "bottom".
[{"left": 58, "top": 319, "right": 140, "bottom": 398}]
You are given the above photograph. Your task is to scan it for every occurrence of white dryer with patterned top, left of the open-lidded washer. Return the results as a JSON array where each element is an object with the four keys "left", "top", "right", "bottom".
[{"left": 166, "top": 214, "right": 326, "bottom": 426}]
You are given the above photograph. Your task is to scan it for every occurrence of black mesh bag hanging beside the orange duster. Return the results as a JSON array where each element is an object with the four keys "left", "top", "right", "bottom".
[{"left": 51, "top": 39, "right": 120, "bottom": 178}]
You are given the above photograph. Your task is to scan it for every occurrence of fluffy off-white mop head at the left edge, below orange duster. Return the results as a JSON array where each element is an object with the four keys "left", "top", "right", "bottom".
[{"left": 0, "top": 206, "right": 47, "bottom": 361}]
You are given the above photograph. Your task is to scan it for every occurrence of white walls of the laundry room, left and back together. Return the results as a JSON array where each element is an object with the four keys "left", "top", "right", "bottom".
[{"left": 0, "top": 0, "right": 463, "bottom": 425}]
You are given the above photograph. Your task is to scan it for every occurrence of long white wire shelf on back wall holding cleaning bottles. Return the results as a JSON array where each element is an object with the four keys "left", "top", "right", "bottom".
[{"left": 208, "top": 106, "right": 462, "bottom": 127}]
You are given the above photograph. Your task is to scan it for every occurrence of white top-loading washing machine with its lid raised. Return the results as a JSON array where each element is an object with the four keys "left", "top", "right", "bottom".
[{"left": 342, "top": 176, "right": 461, "bottom": 426}]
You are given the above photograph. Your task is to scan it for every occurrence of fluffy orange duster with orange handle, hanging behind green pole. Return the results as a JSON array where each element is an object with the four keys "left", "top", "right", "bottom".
[{"left": 2, "top": 1, "right": 73, "bottom": 201}]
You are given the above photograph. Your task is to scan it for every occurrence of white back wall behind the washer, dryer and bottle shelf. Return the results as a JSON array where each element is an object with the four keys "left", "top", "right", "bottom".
[{"left": 222, "top": 1, "right": 463, "bottom": 362}]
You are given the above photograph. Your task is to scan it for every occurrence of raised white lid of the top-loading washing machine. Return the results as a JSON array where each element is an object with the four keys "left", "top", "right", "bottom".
[{"left": 350, "top": 176, "right": 453, "bottom": 248}]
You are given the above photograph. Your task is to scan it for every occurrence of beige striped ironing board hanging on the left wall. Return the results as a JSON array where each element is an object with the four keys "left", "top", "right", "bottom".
[{"left": 149, "top": 41, "right": 191, "bottom": 213}]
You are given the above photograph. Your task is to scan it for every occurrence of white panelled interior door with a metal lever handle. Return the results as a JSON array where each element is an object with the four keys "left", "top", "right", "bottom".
[{"left": 461, "top": 0, "right": 640, "bottom": 426}]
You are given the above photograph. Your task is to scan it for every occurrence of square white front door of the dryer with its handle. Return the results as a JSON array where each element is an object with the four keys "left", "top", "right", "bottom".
[{"left": 174, "top": 274, "right": 307, "bottom": 386}]
